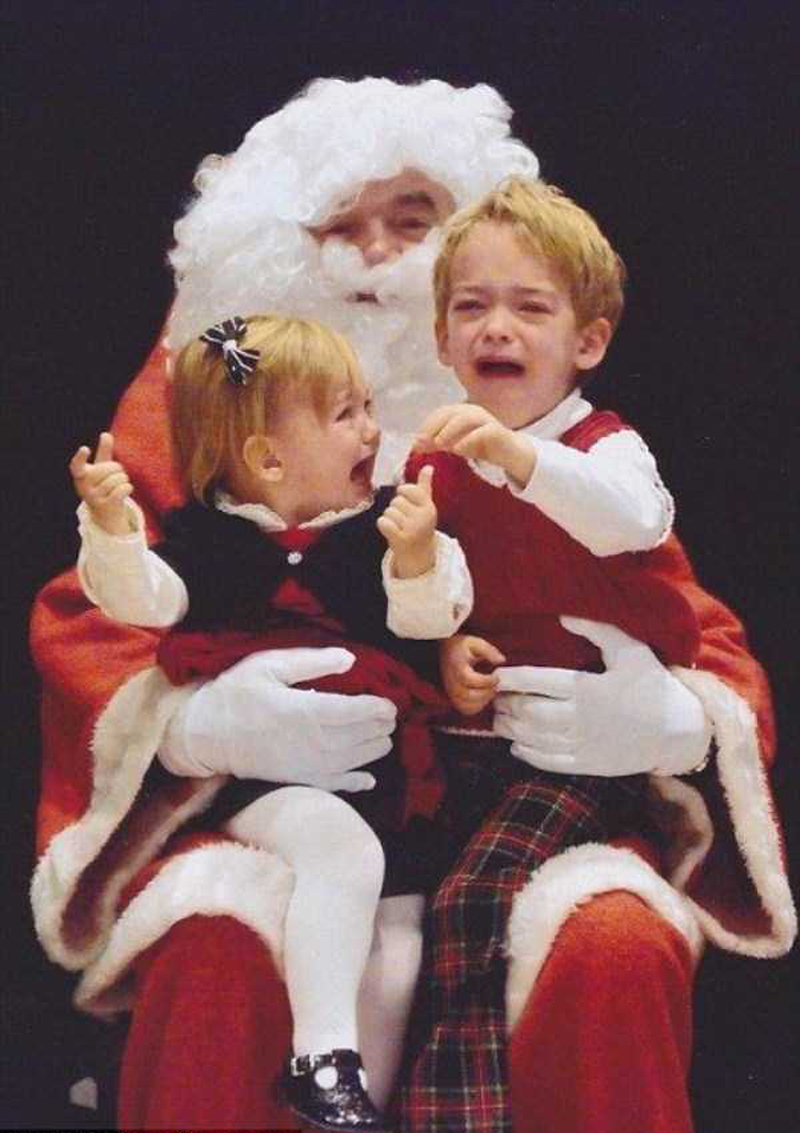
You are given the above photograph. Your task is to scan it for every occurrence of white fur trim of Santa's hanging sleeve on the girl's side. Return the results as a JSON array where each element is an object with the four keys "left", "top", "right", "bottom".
[{"left": 31, "top": 668, "right": 222, "bottom": 970}]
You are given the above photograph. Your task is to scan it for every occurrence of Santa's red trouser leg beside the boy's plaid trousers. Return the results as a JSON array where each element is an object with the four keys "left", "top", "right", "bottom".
[{"left": 509, "top": 893, "right": 693, "bottom": 1133}]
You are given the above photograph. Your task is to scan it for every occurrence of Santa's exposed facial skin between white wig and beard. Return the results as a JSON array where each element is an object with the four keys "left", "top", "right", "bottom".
[{"left": 309, "top": 169, "right": 456, "bottom": 274}]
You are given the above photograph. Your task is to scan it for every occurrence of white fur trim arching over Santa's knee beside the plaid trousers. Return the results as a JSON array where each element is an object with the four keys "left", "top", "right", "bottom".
[{"left": 505, "top": 842, "right": 703, "bottom": 1030}]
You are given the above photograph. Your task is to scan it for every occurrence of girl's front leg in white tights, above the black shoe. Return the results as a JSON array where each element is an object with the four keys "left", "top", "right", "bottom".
[{"left": 227, "top": 786, "right": 384, "bottom": 1055}]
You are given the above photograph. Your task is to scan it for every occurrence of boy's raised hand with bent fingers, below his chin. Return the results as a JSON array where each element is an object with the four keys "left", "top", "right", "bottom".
[{"left": 414, "top": 403, "right": 536, "bottom": 485}]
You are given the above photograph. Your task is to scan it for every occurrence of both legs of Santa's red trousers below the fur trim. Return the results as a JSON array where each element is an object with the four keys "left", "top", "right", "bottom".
[{"left": 119, "top": 893, "right": 692, "bottom": 1133}]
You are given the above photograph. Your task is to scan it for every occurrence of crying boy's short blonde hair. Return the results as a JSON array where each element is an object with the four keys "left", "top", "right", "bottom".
[{"left": 433, "top": 177, "right": 625, "bottom": 332}]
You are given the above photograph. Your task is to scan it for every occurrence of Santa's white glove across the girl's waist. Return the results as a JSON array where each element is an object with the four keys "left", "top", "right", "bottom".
[{"left": 159, "top": 648, "right": 397, "bottom": 791}]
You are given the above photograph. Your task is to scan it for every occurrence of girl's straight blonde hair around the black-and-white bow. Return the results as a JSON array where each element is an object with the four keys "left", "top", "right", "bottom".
[{"left": 171, "top": 315, "right": 361, "bottom": 504}]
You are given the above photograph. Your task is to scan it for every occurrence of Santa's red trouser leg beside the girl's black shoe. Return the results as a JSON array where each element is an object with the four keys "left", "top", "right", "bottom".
[{"left": 118, "top": 917, "right": 298, "bottom": 1130}]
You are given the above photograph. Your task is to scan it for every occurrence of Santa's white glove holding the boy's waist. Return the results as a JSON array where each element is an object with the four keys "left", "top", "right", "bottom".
[{"left": 494, "top": 617, "right": 712, "bottom": 776}]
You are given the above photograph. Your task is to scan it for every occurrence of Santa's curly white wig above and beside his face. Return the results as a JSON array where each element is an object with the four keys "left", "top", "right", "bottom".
[{"left": 169, "top": 78, "right": 538, "bottom": 349}]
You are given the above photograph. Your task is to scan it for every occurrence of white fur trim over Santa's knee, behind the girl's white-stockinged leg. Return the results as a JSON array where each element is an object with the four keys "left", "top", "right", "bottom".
[{"left": 75, "top": 842, "right": 293, "bottom": 1015}]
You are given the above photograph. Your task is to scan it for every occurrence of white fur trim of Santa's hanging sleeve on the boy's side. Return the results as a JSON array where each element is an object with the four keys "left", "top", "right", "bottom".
[{"left": 650, "top": 668, "right": 798, "bottom": 959}]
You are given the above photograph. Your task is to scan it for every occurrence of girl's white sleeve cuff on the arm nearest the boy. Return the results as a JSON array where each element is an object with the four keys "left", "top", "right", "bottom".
[{"left": 381, "top": 531, "right": 473, "bottom": 640}]
